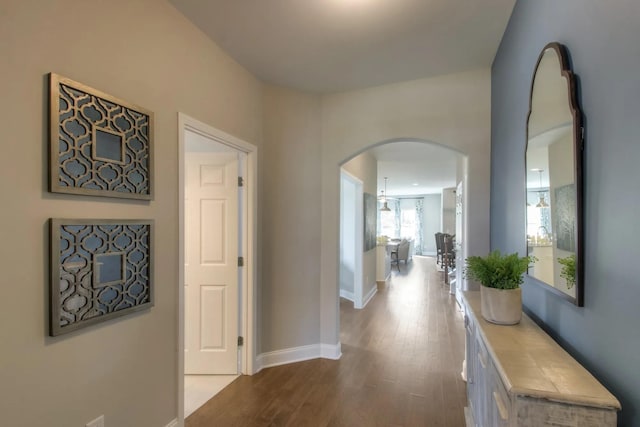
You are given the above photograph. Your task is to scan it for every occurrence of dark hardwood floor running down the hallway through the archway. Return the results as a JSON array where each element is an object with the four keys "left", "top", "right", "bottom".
[{"left": 185, "top": 257, "right": 466, "bottom": 427}]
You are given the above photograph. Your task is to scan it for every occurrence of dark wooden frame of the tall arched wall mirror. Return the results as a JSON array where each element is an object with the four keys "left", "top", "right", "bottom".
[{"left": 524, "top": 42, "right": 584, "bottom": 307}]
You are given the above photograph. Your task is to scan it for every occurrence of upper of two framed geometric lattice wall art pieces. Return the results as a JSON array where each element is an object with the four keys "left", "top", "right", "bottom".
[{"left": 49, "top": 73, "right": 153, "bottom": 200}]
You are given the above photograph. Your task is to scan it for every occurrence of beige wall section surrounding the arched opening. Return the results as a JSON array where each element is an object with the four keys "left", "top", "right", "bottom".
[{"left": 321, "top": 69, "right": 491, "bottom": 345}]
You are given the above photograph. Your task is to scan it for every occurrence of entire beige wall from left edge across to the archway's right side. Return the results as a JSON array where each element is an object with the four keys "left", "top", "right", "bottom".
[{"left": 0, "top": 0, "right": 490, "bottom": 427}]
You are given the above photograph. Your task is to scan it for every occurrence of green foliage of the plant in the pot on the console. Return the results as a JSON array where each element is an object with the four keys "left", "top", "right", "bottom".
[{"left": 465, "top": 250, "right": 536, "bottom": 289}]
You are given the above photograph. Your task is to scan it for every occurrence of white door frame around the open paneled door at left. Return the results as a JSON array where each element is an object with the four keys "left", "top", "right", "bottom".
[{"left": 176, "top": 113, "right": 258, "bottom": 426}]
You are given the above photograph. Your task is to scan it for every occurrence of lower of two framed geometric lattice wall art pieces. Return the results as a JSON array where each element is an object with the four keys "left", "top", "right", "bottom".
[{"left": 49, "top": 219, "right": 154, "bottom": 336}]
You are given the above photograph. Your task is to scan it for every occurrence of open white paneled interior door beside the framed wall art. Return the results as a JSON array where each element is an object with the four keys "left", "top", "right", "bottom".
[{"left": 184, "top": 153, "right": 238, "bottom": 374}]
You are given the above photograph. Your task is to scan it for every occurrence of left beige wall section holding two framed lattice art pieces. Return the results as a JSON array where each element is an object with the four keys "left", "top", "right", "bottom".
[{"left": 0, "top": 0, "right": 262, "bottom": 427}]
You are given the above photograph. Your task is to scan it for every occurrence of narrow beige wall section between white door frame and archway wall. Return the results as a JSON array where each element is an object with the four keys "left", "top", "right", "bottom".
[{"left": 260, "top": 86, "right": 320, "bottom": 353}]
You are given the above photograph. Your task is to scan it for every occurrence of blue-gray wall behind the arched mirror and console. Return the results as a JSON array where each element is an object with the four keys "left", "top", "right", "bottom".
[{"left": 491, "top": 0, "right": 640, "bottom": 426}]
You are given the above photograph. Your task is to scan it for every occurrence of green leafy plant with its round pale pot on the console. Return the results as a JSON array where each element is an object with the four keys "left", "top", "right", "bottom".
[{"left": 465, "top": 250, "right": 535, "bottom": 325}]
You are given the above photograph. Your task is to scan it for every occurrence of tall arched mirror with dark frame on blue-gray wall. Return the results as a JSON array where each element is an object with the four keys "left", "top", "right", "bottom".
[{"left": 525, "top": 43, "right": 584, "bottom": 306}]
